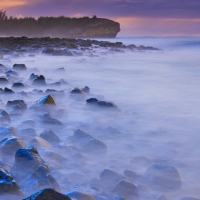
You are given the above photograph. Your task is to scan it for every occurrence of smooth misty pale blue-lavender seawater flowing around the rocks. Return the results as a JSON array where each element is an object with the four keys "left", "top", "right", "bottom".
[{"left": 1, "top": 37, "right": 200, "bottom": 200}]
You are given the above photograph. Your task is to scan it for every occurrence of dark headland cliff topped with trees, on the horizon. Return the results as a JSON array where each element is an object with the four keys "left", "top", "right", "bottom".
[{"left": 0, "top": 10, "right": 120, "bottom": 38}]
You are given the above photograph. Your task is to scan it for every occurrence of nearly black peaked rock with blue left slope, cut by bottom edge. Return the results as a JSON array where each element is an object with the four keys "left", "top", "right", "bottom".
[{"left": 23, "top": 188, "right": 71, "bottom": 200}]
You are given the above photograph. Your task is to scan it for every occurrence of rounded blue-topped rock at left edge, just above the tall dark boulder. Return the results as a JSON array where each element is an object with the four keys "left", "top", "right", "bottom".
[{"left": 0, "top": 137, "right": 25, "bottom": 155}]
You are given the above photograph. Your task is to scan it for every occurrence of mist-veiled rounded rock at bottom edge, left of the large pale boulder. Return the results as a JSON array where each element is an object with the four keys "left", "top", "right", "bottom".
[{"left": 112, "top": 180, "right": 140, "bottom": 200}]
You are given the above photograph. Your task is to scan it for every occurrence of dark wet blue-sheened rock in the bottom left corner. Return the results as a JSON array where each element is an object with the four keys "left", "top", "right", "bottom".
[{"left": 0, "top": 167, "right": 24, "bottom": 197}]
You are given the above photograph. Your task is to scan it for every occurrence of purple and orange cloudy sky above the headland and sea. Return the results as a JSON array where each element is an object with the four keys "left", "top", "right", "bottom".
[{"left": 0, "top": 0, "right": 200, "bottom": 36}]
